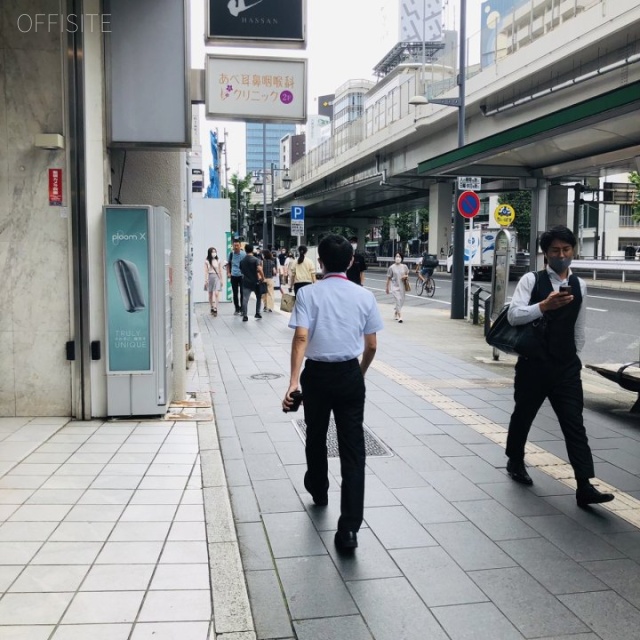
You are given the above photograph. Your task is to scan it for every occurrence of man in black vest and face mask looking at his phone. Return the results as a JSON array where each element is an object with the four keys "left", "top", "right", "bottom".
[{"left": 506, "top": 225, "right": 614, "bottom": 507}]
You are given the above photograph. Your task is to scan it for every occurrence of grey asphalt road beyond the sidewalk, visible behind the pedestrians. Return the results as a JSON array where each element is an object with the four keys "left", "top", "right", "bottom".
[{"left": 365, "top": 269, "right": 640, "bottom": 364}]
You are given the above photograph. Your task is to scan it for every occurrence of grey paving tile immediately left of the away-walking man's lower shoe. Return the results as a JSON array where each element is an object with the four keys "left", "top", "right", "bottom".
[{"left": 263, "top": 511, "right": 327, "bottom": 558}]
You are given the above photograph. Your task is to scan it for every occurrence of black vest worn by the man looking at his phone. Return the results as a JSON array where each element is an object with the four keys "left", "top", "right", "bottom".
[{"left": 529, "top": 269, "right": 582, "bottom": 360}]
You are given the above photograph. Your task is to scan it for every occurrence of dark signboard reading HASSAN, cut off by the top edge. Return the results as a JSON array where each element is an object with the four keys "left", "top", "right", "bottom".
[{"left": 206, "top": 0, "right": 306, "bottom": 49}]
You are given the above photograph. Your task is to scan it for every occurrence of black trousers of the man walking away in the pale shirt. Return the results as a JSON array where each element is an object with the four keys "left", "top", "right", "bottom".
[{"left": 300, "top": 359, "right": 365, "bottom": 531}]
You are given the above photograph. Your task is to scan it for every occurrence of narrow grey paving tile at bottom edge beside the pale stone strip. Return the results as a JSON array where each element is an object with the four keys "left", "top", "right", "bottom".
[{"left": 245, "top": 570, "right": 293, "bottom": 638}]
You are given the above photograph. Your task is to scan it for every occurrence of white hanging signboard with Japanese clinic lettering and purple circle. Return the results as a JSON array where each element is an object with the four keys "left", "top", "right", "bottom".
[{"left": 205, "top": 54, "right": 307, "bottom": 123}]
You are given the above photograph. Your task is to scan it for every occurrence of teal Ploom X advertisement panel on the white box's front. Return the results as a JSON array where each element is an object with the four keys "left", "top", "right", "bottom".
[{"left": 104, "top": 207, "right": 152, "bottom": 373}]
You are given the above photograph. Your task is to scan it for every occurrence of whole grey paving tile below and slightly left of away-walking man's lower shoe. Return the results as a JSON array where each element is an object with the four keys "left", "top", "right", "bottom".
[{"left": 276, "top": 555, "right": 358, "bottom": 620}]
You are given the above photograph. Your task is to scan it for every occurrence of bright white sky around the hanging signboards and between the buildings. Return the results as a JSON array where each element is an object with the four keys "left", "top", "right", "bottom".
[{"left": 191, "top": 0, "right": 481, "bottom": 179}]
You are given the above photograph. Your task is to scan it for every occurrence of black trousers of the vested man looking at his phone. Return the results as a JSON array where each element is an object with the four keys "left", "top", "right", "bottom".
[{"left": 506, "top": 356, "right": 595, "bottom": 479}]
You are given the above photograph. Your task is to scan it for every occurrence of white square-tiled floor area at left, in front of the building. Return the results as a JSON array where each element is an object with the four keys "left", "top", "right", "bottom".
[{"left": 0, "top": 418, "right": 212, "bottom": 640}]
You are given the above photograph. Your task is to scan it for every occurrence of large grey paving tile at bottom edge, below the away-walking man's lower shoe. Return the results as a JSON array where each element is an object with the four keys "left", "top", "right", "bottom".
[{"left": 348, "top": 578, "right": 447, "bottom": 640}]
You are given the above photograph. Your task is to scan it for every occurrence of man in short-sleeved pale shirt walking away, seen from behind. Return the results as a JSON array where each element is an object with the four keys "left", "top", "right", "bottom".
[{"left": 282, "top": 235, "right": 382, "bottom": 551}]
